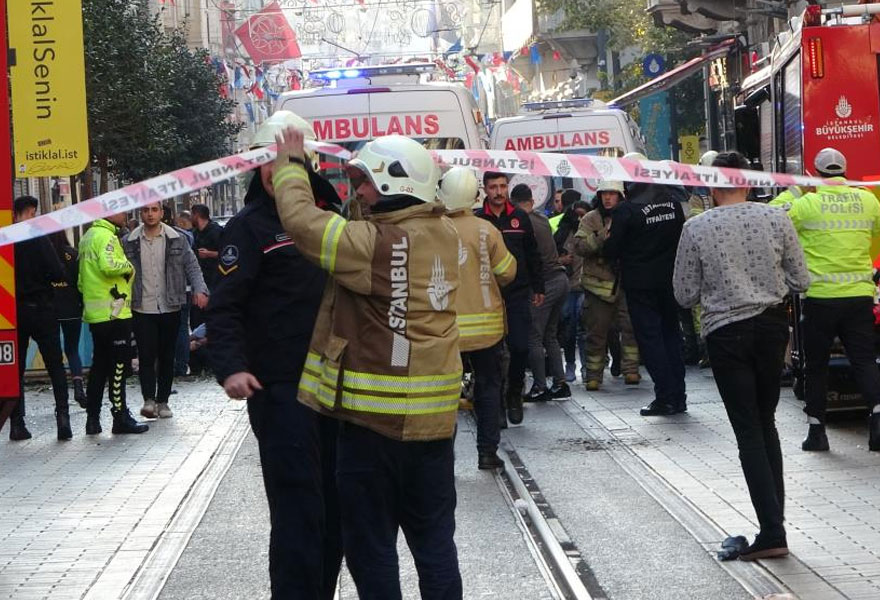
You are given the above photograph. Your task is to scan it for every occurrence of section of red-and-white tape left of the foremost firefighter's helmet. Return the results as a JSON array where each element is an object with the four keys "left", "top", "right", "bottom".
[{"left": 0, "top": 141, "right": 351, "bottom": 246}]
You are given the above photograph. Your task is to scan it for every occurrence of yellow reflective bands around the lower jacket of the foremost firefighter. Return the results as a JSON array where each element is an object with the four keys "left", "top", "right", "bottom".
[{"left": 300, "top": 352, "right": 461, "bottom": 415}]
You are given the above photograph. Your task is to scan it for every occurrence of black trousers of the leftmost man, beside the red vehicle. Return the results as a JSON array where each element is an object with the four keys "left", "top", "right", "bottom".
[{"left": 11, "top": 302, "right": 69, "bottom": 421}]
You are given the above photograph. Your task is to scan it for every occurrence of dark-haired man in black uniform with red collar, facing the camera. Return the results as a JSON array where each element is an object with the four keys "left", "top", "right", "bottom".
[{"left": 477, "top": 171, "right": 544, "bottom": 425}]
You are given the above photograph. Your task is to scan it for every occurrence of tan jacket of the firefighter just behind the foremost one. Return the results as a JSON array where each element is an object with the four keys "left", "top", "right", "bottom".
[{"left": 448, "top": 209, "right": 516, "bottom": 352}]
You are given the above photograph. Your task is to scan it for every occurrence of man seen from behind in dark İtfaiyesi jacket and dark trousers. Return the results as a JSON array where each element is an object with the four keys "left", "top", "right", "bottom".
[{"left": 604, "top": 183, "right": 688, "bottom": 416}]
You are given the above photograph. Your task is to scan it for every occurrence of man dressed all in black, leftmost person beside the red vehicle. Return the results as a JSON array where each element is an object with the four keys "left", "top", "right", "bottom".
[{"left": 9, "top": 196, "right": 73, "bottom": 441}]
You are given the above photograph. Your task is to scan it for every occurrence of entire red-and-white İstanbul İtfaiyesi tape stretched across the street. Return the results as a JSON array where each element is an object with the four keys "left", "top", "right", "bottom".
[{"left": 0, "top": 141, "right": 880, "bottom": 246}]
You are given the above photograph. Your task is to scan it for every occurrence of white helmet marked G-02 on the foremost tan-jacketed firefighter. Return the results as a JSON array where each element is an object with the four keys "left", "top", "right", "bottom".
[{"left": 348, "top": 135, "right": 440, "bottom": 202}]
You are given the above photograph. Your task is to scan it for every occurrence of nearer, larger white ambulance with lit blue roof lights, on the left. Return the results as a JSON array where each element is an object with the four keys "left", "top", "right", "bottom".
[{"left": 275, "top": 62, "right": 488, "bottom": 199}]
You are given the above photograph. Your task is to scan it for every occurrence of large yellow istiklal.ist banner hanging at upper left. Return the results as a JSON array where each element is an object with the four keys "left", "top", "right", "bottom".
[{"left": 7, "top": 0, "right": 89, "bottom": 177}]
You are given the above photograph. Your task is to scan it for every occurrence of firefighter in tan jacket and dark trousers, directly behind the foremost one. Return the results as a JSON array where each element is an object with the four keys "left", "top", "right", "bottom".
[{"left": 439, "top": 167, "right": 516, "bottom": 469}]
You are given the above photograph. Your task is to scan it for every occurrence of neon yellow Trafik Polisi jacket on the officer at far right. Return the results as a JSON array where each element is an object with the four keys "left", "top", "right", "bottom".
[{"left": 788, "top": 179, "right": 880, "bottom": 298}]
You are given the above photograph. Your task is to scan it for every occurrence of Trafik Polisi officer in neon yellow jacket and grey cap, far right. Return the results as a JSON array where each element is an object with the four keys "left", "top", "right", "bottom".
[{"left": 788, "top": 148, "right": 880, "bottom": 451}]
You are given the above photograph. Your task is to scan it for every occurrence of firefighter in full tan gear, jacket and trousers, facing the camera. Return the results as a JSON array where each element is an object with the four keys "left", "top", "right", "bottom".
[{"left": 574, "top": 181, "right": 642, "bottom": 391}]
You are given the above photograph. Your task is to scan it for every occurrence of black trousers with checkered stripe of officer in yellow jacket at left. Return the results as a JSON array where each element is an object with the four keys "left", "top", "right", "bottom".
[{"left": 86, "top": 319, "right": 131, "bottom": 416}]
